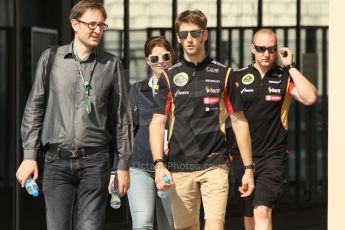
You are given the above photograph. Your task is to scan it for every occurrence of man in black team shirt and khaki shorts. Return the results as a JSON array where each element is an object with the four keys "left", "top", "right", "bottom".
[{"left": 150, "top": 10, "right": 254, "bottom": 230}]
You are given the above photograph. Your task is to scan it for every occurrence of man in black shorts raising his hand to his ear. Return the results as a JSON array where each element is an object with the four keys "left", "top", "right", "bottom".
[{"left": 232, "top": 29, "right": 316, "bottom": 230}]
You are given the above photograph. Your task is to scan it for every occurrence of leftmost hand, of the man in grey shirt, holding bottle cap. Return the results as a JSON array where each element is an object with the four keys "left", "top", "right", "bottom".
[{"left": 16, "top": 160, "right": 38, "bottom": 188}]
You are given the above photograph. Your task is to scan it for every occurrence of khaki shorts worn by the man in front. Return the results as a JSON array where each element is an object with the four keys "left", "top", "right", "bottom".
[{"left": 171, "top": 164, "right": 229, "bottom": 229}]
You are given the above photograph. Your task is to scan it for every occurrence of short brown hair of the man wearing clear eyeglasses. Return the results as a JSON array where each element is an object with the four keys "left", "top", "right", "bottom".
[{"left": 69, "top": 0, "right": 107, "bottom": 20}]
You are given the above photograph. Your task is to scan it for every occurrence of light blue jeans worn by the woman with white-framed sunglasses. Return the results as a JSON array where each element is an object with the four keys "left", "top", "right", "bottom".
[{"left": 127, "top": 168, "right": 174, "bottom": 230}]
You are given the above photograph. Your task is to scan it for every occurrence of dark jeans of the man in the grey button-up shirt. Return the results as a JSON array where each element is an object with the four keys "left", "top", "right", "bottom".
[{"left": 43, "top": 151, "right": 109, "bottom": 230}]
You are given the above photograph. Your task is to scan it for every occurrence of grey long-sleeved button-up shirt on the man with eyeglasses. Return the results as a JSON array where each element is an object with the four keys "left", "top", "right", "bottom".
[{"left": 21, "top": 43, "right": 133, "bottom": 169}]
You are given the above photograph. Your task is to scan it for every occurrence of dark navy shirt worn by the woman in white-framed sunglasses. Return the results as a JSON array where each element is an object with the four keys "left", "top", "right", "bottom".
[{"left": 129, "top": 78, "right": 154, "bottom": 171}]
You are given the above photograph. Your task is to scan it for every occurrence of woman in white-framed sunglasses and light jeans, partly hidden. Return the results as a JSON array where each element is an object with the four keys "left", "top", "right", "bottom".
[{"left": 127, "top": 36, "right": 175, "bottom": 230}]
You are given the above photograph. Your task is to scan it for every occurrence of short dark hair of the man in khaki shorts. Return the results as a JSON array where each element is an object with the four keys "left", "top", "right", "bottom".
[{"left": 175, "top": 9, "right": 207, "bottom": 32}]
